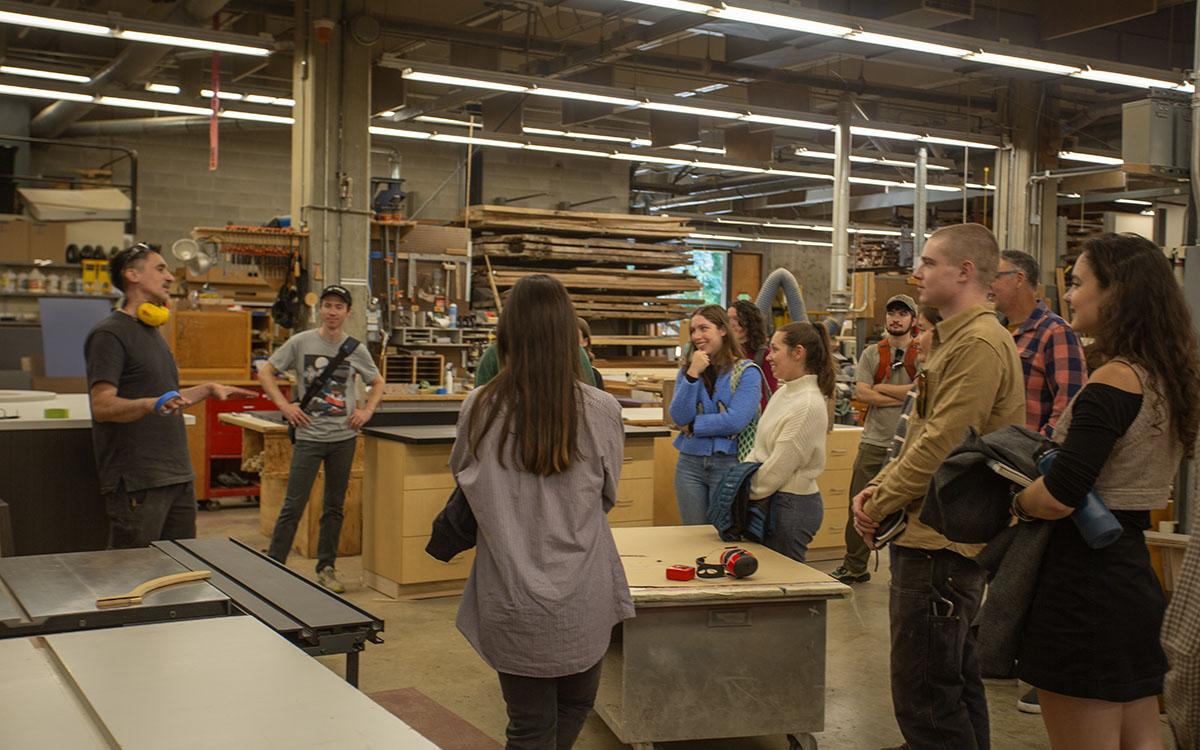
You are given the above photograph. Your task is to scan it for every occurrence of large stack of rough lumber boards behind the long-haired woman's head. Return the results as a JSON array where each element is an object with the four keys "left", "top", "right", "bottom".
[{"left": 466, "top": 205, "right": 703, "bottom": 359}]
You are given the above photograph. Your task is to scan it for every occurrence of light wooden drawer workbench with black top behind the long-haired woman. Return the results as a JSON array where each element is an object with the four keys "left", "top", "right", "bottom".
[{"left": 362, "top": 425, "right": 666, "bottom": 596}]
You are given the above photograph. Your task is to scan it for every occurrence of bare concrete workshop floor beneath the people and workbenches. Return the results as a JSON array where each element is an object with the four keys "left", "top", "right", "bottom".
[{"left": 198, "top": 508, "right": 1161, "bottom": 750}]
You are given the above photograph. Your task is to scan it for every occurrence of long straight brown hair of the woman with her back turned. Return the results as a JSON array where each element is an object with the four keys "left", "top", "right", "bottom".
[{"left": 467, "top": 274, "right": 582, "bottom": 476}]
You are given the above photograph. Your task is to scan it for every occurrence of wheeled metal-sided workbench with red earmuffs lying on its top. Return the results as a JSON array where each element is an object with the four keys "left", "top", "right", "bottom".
[{"left": 595, "top": 526, "right": 850, "bottom": 750}]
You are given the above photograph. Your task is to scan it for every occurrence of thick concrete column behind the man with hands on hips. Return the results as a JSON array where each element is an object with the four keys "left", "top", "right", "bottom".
[{"left": 292, "top": 0, "right": 378, "bottom": 341}]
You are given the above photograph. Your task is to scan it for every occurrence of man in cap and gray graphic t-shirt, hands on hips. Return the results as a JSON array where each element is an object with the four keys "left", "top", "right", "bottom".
[{"left": 258, "top": 284, "right": 383, "bottom": 594}]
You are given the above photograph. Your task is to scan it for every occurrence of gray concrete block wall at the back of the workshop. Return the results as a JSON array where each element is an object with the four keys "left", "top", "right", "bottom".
[{"left": 25, "top": 128, "right": 629, "bottom": 246}]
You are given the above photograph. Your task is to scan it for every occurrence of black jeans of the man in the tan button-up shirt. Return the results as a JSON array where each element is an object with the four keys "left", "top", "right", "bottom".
[{"left": 889, "top": 545, "right": 991, "bottom": 750}]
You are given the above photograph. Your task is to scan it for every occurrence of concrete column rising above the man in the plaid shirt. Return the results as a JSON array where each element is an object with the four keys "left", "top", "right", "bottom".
[{"left": 995, "top": 80, "right": 1040, "bottom": 252}]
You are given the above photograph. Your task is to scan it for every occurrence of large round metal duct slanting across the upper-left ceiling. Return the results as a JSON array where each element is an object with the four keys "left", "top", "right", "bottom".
[{"left": 29, "top": 0, "right": 229, "bottom": 138}]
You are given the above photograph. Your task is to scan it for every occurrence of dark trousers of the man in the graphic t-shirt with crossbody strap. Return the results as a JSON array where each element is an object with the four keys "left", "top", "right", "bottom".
[{"left": 268, "top": 438, "right": 358, "bottom": 571}]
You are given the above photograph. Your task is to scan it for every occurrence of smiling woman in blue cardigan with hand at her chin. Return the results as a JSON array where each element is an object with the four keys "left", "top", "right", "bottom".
[{"left": 671, "top": 305, "right": 762, "bottom": 526}]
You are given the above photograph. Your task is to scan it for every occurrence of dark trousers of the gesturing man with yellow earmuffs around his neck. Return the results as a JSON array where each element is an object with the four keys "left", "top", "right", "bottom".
[{"left": 104, "top": 481, "right": 196, "bottom": 550}]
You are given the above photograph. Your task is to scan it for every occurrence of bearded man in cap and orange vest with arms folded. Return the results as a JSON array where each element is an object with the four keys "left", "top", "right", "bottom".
[{"left": 829, "top": 294, "right": 917, "bottom": 583}]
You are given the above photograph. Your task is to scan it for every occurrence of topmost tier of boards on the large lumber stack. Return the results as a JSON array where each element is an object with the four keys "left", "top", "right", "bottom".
[{"left": 464, "top": 205, "right": 688, "bottom": 239}]
